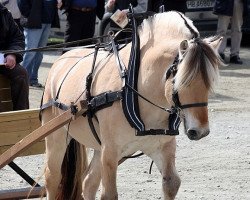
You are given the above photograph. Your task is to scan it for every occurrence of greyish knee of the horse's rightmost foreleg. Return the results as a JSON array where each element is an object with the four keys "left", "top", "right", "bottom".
[{"left": 162, "top": 174, "right": 181, "bottom": 200}]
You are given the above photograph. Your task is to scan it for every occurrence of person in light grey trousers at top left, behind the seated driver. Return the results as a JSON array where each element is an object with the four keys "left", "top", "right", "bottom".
[{"left": 0, "top": 0, "right": 23, "bottom": 31}]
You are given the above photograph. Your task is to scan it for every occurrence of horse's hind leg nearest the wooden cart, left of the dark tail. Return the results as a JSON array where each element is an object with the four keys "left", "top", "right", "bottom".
[{"left": 45, "top": 129, "right": 67, "bottom": 200}]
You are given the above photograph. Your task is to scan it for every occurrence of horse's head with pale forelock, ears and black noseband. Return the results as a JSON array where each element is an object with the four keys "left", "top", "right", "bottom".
[{"left": 170, "top": 38, "right": 221, "bottom": 140}]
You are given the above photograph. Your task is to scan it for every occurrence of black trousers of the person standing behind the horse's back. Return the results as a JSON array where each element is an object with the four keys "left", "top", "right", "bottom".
[{"left": 65, "top": 9, "right": 96, "bottom": 46}]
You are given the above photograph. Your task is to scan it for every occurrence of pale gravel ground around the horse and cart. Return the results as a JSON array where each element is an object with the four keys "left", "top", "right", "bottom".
[{"left": 0, "top": 48, "right": 250, "bottom": 200}]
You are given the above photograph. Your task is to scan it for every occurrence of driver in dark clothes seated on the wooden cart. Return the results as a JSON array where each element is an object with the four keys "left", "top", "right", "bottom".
[{"left": 0, "top": 3, "right": 29, "bottom": 110}]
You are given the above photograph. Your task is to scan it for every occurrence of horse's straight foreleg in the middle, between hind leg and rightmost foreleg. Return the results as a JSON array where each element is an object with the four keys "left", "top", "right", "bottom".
[{"left": 101, "top": 144, "right": 118, "bottom": 200}]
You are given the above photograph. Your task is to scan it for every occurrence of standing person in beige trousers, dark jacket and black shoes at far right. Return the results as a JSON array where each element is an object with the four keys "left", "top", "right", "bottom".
[{"left": 213, "top": 0, "right": 247, "bottom": 64}]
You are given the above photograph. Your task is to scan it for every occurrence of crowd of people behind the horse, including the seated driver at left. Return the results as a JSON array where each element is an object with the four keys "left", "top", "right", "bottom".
[{"left": 0, "top": 0, "right": 247, "bottom": 110}]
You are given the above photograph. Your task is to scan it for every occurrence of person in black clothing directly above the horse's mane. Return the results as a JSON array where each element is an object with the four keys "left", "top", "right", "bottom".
[{"left": 152, "top": 0, "right": 187, "bottom": 13}]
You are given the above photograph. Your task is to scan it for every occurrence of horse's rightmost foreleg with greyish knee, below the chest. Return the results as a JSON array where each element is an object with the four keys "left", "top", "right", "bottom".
[{"left": 149, "top": 138, "right": 181, "bottom": 200}]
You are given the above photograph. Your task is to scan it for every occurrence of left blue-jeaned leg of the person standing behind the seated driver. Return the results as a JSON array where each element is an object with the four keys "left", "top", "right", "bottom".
[{"left": 22, "top": 28, "right": 42, "bottom": 83}]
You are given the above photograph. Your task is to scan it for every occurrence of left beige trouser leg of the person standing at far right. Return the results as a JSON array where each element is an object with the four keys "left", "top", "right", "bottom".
[{"left": 217, "top": 15, "right": 230, "bottom": 54}]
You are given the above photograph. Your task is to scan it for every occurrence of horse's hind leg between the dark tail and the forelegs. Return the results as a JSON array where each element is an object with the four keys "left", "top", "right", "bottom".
[{"left": 82, "top": 150, "right": 101, "bottom": 200}]
